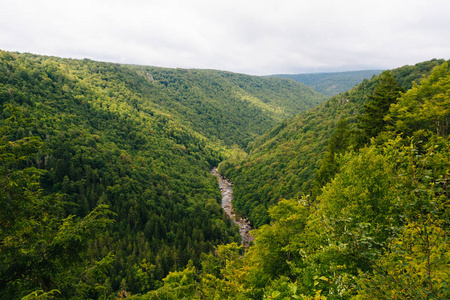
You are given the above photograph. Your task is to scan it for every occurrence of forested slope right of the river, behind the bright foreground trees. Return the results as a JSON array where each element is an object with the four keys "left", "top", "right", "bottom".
[{"left": 225, "top": 60, "right": 443, "bottom": 226}]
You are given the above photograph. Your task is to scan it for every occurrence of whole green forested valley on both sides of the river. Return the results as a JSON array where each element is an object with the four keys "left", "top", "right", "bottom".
[{"left": 0, "top": 51, "right": 450, "bottom": 299}]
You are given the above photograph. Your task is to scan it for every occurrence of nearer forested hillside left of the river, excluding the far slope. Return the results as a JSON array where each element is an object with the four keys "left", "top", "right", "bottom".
[{"left": 0, "top": 52, "right": 246, "bottom": 299}]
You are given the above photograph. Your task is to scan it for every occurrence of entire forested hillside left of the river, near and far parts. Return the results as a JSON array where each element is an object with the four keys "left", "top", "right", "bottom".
[{"left": 0, "top": 51, "right": 325, "bottom": 299}]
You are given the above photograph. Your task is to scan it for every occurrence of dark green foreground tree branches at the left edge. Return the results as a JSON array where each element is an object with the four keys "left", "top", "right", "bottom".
[{"left": 0, "top": 106, "right": 111, "bottom": 299}]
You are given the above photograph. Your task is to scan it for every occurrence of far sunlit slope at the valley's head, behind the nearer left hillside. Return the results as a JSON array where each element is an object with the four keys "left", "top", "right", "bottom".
[{"left": 74, "top": 60, "right": 326, "bottom": 146}]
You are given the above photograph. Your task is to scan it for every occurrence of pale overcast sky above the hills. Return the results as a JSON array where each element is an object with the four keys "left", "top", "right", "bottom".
[{"left": 0, "top": 0, "right": 450, "bottom": 75}]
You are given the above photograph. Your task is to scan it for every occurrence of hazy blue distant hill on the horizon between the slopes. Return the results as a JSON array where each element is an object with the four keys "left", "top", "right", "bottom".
[{"left": 272, "top": 70, "right": 382, "bottom": 96}]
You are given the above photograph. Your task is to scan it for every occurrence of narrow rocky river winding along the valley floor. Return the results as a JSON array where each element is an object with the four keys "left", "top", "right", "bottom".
[{"left": 211, "top": 168, "right": 254, "bottom": 248}]
